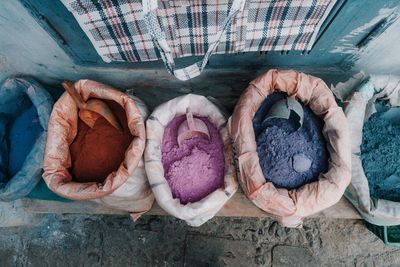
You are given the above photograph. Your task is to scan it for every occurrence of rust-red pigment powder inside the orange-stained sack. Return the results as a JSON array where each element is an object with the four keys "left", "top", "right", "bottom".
[{"left": 70, "top": 100, "right": 133, "bottom": 183}]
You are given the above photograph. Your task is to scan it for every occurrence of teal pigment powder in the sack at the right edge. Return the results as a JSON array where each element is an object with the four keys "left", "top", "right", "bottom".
[{"left": 361, "top": 103, "right": 400, "bottom": 202}]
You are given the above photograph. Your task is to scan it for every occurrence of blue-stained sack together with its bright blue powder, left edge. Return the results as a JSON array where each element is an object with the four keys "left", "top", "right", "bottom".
[{"left": 0, "top": 78, "right": 53, "bottom": 201}]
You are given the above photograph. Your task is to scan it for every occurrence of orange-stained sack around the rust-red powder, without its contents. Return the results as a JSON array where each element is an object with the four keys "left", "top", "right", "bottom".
[{"left": 43, "top": 80, "right": 154, "bottom": 217}]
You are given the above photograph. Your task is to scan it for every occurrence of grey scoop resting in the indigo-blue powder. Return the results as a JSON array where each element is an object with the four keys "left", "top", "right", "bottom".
[{"left": 262, "top": 97, "right": 304, "bottom": 130}]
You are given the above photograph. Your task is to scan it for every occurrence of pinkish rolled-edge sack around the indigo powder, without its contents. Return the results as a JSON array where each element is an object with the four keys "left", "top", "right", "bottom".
[{"left": 229, "top": 70, "right": 351, "bottom": 227}]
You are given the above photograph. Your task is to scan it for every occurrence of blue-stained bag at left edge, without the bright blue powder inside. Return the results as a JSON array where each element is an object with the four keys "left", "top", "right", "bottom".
[{"left": 0, "top": 78, "right": 53, "bottom": 201}]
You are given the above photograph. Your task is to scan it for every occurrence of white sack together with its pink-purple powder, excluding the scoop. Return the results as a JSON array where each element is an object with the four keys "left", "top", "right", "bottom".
[{"left": 145, "top": 94, "right": 238, "bottom": 226}]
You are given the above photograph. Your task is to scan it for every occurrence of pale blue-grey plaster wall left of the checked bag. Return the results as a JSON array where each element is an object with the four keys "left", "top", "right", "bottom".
[{"left": 0, "top": 1, "right": 162, "bottom": 87}]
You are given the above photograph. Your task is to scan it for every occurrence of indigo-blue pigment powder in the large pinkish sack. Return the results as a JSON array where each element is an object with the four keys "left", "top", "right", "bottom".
[{"left": 253, "top": 93, "right": 328, "bottom": 189}]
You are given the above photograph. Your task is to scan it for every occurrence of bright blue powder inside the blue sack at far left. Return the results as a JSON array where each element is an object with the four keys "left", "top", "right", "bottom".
[{"left": 8, "top": 105, "right": 43, "bottom": 177}]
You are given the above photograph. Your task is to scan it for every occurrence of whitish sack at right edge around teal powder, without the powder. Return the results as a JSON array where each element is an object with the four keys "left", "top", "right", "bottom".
[{"left": 344, "top": 75, "right": 400, "bottom": 225}]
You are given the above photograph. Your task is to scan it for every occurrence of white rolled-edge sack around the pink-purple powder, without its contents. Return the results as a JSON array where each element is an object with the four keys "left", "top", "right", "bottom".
[{"left": 144, "top": 94, "right": 238, "bottom": 226}]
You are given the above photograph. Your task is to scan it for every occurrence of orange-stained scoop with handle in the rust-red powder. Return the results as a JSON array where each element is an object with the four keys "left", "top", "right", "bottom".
[{"left": 62, "top": 81, "right": 122, "bottom": 131}]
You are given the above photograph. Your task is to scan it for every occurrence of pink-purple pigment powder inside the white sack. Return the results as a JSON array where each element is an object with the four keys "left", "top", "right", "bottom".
[{"left": 161, "top": 115, "right": 225, "bottom": 204}]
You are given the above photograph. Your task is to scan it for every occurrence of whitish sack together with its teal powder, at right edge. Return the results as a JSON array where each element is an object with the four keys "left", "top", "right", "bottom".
[{"left": 342, "top": 75, "right": 400, "bottom": 226}]
